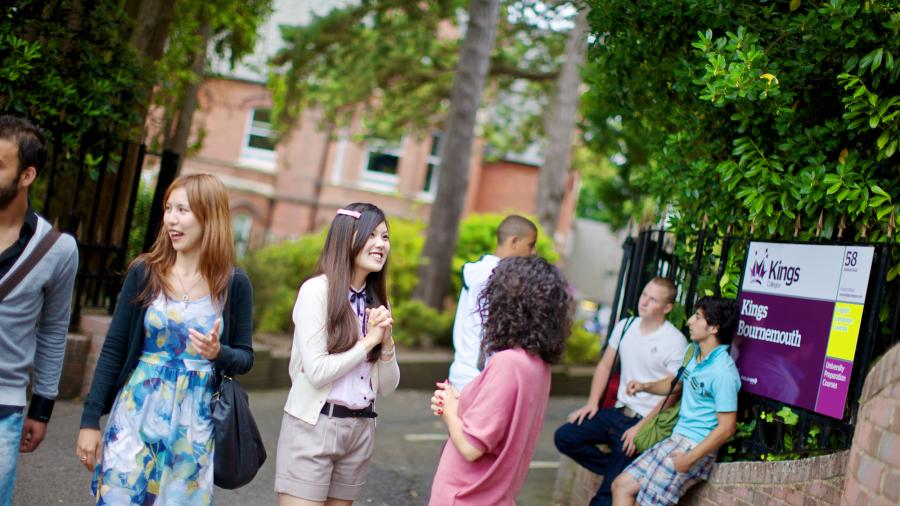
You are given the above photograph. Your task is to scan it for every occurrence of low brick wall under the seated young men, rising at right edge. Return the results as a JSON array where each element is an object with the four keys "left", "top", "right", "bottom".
[{"left": 553, "top": 345, "right": 900, "bottom": 506}]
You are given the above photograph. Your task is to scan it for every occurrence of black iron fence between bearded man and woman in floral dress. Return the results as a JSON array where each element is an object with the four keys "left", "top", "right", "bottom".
[{"left": 31, "top": 126, "right": 178, "bottom": 325}]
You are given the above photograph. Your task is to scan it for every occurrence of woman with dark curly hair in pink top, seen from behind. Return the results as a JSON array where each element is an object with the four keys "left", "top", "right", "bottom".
[{"left": 429, "top": 256, "right": 572, "bottom": 506}]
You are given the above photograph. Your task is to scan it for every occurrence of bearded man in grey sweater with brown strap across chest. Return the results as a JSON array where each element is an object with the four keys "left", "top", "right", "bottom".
[{"left": 0, "top": 115, "right": 78, "bottom": 505}]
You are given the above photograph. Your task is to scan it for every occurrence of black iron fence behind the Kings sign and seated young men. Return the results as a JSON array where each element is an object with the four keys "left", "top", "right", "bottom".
[{"left": 608, "top": 228, "right": 900, "bottom": 460}]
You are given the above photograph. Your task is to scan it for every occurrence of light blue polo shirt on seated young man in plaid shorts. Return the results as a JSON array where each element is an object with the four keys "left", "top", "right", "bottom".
[{"left": 672, "top": 344, "right": 741, "bottom": 443}]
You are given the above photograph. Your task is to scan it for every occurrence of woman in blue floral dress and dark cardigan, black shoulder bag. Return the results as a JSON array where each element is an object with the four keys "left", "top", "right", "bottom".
[{"left": 76, "top": 174, "right": 253, "bottom": 505}]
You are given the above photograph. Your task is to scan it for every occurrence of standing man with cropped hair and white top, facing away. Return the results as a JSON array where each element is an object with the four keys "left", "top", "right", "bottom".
[{"left": 449, "top": 214, "right": 537, "bottom": 391}]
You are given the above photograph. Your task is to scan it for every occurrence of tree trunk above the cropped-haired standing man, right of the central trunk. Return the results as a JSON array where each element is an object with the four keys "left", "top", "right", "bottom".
[{"left": 534, "top": 6, "right": 590, "bottom": 235}]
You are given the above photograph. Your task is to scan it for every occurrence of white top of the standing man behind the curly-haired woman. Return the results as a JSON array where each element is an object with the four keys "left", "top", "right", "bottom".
[{"left": 450, "top": 255, "right": 500, "bottom": 391}]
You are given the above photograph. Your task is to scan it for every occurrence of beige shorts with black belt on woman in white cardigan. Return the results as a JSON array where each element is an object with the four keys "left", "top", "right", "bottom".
[{"left": 275, "top": 413, "right": 375, "bottom": 502}]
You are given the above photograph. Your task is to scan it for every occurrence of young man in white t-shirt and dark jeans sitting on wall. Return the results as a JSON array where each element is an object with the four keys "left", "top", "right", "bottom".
[{"left": 554, "top": 278, "right": 688, "bottom": 506}]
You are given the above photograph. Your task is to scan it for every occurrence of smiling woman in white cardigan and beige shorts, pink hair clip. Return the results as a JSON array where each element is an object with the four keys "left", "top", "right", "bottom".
[{"left": 275, "top": 203, "right": 400, "bottom": 506}]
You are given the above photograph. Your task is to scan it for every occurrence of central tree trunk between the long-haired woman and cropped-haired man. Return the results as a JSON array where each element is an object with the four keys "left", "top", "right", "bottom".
[{"left": 413, "top": 0, "right": 500, "bottom": 309}]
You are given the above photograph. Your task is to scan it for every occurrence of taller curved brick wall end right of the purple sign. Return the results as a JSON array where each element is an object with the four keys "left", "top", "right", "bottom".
[{"left": 841, "top": 345, "right": 900, "bottom": 505}]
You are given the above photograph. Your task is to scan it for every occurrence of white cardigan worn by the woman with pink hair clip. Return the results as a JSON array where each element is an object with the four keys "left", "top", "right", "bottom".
[{"left": 284, "top": 275, "right": 400, "bottom": 425}]
